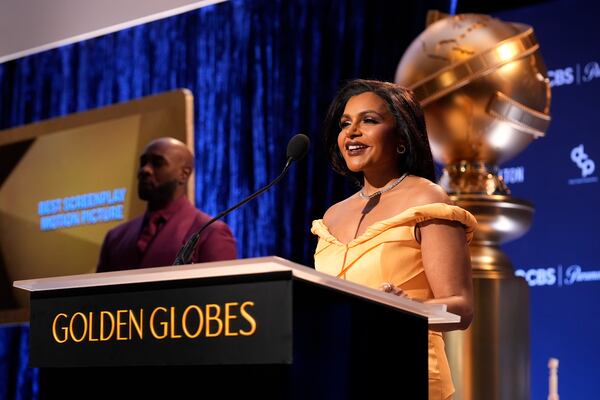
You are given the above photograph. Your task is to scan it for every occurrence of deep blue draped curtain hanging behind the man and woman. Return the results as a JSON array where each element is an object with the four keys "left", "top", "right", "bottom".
[{"left": 0, "top": 0, "right": 452, "bottom": 398}]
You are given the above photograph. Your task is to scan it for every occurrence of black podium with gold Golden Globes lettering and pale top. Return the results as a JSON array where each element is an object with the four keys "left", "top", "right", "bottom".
[{"left": 14, "top": 257, "right": 458, "bottom": 399}]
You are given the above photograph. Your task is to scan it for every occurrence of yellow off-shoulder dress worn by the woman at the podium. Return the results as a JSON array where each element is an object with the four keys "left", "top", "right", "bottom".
[{"left": 311, "top": 203, "right": 477, "bottom": 400}]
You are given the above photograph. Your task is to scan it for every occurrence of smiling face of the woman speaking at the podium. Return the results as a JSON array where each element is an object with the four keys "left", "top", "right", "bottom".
[{"left": 338, "top": 92, "right": 400, "bottom": 177}]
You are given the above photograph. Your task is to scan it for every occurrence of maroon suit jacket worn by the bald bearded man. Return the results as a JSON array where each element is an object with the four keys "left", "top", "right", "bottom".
[{"left": 98, "top": 197, "right": 236, "bottom": 272}]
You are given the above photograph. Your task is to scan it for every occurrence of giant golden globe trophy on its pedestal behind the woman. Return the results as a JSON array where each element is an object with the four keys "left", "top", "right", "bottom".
[{"left": 396, "top": 11, "right": 550, "bottom": 400}]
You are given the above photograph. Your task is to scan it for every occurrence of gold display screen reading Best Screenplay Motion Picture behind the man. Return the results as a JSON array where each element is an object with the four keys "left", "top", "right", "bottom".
[{"left": 0, "top": 90, "right": 194, "bottom": 308}]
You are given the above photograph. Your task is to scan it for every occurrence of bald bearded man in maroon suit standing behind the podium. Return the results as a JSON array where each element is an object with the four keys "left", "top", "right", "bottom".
[{"left": 98, "top": 138, "right": 236, "bottom": 272}]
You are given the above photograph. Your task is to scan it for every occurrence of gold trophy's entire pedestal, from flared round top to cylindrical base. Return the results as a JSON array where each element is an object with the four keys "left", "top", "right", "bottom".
[{"left": 446, "top": 194, "right": 534, "bottom": 400}]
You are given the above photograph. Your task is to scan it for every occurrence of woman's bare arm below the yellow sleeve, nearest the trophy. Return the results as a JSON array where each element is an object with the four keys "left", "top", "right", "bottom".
[{"left": 416, "top": 219, "right": 473, "bottom": 331}]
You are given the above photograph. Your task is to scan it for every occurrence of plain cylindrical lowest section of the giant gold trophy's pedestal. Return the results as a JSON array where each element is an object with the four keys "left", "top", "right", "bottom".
[{"left": 445, "top": 270, "right": 530, "bottom": 400}]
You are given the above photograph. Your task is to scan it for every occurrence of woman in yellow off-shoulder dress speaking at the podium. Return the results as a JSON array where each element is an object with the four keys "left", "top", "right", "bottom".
[{"left": 311, "top": 80, "right": 476, "bottom": 400}]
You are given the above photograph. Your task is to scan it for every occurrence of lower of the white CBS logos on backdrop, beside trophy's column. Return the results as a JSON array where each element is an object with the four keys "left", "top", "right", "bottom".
[{"left": 515, "top": 264, "right": 600, "bottom": 287}]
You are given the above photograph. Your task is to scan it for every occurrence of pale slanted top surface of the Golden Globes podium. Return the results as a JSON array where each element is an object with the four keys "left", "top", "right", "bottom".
[{"left": 13, "top": 257, "right": 460, "bottom": 324}]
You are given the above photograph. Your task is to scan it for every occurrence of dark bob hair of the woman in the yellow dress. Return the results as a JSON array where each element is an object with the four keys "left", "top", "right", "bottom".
[{"left": 324, "top": 79, "right": 435, "bottom": 185}]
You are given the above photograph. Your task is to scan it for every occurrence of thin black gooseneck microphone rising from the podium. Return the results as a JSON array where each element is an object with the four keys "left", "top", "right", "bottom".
[{"left": 173, "top": 133, "right": 310, "bottom": 265}]
